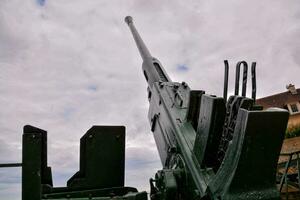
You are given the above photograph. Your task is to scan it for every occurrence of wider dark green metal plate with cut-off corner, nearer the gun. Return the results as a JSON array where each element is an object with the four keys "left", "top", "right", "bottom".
[{"left": 67, "top": 126, "right": 125, "bottom": 188}]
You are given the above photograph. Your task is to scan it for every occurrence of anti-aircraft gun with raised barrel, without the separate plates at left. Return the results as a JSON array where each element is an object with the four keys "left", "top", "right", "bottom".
[{"left": 125, "top": 16, "right": 288, "bottom": 200}]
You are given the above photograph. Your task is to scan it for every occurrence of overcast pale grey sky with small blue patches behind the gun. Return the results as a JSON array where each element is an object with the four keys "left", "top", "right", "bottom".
[{"left": 0, "top": 0, "right": 300, "bottom": 199}]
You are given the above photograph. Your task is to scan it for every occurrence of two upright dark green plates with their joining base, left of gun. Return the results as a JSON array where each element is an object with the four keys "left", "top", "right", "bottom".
[{"left": 22, "top": 125, "right": 147, "bottom": 200}]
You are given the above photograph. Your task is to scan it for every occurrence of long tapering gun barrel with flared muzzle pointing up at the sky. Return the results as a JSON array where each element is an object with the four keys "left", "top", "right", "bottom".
[{"left": 125, "top": 16, "right": 171, "bottom": 87}]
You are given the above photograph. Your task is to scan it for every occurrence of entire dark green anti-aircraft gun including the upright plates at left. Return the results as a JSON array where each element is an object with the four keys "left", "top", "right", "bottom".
[{"left": 0, "top": 16, "right": 288, "bottom": 200}]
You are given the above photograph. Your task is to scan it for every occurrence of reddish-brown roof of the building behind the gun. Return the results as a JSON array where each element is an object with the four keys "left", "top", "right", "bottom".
[{"left": 256, "top": 88, "right": 300, "bottom": 108}]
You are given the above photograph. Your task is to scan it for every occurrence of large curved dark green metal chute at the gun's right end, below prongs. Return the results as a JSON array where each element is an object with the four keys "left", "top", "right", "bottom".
[{"left": 209, "top": 109, "right": 288, "bottom": 200}]
